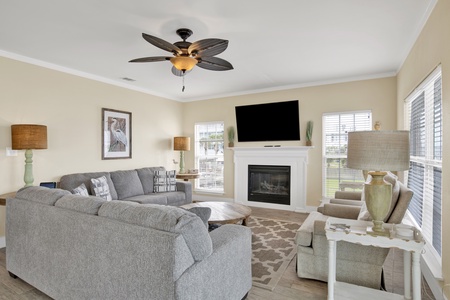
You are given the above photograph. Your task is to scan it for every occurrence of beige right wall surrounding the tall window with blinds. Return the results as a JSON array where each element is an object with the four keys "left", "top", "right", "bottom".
[{"left": 397, "top": 0, "right": 450, "bottom": 298}]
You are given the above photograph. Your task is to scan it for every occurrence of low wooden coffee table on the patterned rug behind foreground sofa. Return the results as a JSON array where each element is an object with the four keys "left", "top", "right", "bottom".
[{"left": 181, "top": 201, "right": 252, "bottom": 226}]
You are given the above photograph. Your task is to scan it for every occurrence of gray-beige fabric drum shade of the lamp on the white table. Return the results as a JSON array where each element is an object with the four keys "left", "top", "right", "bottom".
[{"left": 347, "top": 130, "right": 409, "bottom": 171}]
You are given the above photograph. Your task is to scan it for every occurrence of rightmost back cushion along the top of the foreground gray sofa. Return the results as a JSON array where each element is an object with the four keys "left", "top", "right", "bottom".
[{"left": 98, "top": 201, "right": 212, "bottom": 261}]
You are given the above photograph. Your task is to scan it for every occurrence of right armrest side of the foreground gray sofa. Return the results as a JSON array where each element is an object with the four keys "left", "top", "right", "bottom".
[{"left": 175, "top": 225, "right": 252, "bottom": 299}]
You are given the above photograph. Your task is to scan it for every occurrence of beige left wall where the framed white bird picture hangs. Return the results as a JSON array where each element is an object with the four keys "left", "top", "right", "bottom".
[{"left": 0, "top": 57, "right": 183, "bottom": 244}]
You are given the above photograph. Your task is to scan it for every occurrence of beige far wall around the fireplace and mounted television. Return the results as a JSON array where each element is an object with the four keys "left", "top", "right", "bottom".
[{"left": 184, "top": 77, "right": 397, "bottom": 206}]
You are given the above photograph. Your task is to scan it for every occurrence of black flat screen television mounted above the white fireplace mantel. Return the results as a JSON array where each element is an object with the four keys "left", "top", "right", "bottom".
[{"left": 235, "top": 100, "right": 300, "bottom": 142}]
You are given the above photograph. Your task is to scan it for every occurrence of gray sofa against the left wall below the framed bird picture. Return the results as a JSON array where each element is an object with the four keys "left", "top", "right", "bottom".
[{"left": 59, "top": 167, "right": 192, "bottom": 206}]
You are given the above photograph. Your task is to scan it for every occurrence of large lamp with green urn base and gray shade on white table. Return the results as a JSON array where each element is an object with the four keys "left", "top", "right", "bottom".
[{"left": 347, "top": 130, "right": 409, "bottom": 235}]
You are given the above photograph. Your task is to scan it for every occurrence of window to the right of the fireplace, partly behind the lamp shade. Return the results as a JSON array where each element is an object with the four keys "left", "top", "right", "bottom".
[{"left": 322, "top": 111, "right": 372, "bottom": 198}]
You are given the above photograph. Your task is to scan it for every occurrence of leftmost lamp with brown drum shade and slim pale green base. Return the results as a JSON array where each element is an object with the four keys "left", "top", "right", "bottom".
[{"left": 11, "top": 124, "right": 47, "bottom": 186}]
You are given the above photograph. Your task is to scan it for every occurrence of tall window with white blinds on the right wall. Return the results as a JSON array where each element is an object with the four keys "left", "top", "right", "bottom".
[{"left": 405, "top": 67, "right": 442, "bottom": 261}]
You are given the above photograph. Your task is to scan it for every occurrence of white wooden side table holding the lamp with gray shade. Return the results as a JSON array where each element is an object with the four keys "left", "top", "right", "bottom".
[{"left": 325, "top": 218, "right": 425, "bottom": 300}]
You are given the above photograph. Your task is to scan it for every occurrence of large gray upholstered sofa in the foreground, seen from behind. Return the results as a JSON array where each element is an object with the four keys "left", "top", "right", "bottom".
[{"left": 6, "top": 186, "right": 252, "bottom": 300}]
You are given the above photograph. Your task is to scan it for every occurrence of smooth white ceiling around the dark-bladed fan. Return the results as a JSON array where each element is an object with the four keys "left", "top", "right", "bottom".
[{"left": 0, "top": 0, "right": 436, "bottom": 101}]
